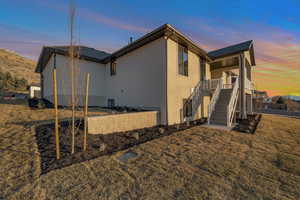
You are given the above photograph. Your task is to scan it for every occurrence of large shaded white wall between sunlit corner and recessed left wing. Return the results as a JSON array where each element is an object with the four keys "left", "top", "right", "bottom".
[{"left": 106, "top": 38, "right": 166, "bottom": 123}]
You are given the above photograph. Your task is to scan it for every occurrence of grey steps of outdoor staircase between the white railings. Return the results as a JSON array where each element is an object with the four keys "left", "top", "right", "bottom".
[{"left": 210, "top": 89, "right": 233, "bottom": 126}]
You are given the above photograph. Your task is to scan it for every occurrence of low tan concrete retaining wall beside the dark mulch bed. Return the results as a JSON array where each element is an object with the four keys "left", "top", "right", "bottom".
[{"left": 88, "top": 111, "right": 160, "bottom": 134}]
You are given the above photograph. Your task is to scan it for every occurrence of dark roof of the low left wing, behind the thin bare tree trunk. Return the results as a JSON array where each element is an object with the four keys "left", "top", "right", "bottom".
[{"left": 35, "top": 46, "right": 110, "bottom": 72}]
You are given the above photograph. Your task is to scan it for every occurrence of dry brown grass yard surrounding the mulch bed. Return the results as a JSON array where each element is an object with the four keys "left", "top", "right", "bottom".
[{"left": 0, "top": 104, "right": 300, "bottom": 200}]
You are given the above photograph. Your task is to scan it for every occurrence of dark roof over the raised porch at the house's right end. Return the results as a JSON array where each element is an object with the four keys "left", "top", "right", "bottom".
[{"left": 208, "top": 40, "right": 255, "bottom": 65}]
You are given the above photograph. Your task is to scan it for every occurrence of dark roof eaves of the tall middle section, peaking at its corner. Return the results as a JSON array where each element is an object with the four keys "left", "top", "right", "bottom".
[{"left": 104, "top": 24, "right": 211, "bottom": 63}]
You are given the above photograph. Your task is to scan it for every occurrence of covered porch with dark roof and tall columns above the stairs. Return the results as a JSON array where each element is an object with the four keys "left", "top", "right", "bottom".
[{"left": 207, "top": 41, "right": 255, "bottom": 119}]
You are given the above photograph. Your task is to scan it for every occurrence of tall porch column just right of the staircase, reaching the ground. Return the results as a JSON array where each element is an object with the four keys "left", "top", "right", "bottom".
[{"left": 239, "top": 53, "right": 247, "bottom": 119}]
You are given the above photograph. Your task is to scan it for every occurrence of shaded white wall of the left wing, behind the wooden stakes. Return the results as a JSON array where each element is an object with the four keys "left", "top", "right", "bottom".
[{"left": 42, "top": 55, "right": 106, "bottom": 106}]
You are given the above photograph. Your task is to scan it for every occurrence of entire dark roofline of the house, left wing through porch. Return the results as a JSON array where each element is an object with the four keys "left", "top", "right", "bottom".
[{"left": 35, "top": 24, "right": 255, "bottom": 73}]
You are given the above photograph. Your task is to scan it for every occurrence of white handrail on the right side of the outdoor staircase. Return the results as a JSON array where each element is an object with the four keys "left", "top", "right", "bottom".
[{"left": 227, "top": 77, "right": 239, "bottom": 127}]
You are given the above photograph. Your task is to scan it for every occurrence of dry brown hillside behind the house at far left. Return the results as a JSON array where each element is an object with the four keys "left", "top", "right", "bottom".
[{"left": 0, "top": 49, "right": 39, "bottom": 84}]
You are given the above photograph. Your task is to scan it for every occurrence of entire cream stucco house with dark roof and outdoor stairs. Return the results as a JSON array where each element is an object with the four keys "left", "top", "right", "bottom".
[{"left": 36, "top": 24, "right": 255, "bottom": 126}]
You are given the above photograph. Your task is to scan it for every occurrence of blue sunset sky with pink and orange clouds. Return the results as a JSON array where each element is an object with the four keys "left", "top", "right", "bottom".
[{"left": 0, "top": 0, "right": 300, "bottom": 96}]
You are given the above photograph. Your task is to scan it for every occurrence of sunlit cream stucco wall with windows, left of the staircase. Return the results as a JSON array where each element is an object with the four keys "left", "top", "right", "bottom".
[{"left": 167, "top": 39, "right": 210, "bottom": 124}]
